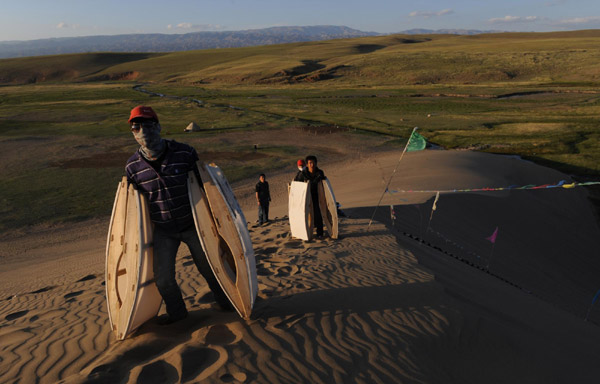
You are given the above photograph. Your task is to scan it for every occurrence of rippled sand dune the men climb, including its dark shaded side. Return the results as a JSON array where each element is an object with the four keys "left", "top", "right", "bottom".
[{"left": 0, "top": 151, "right": 600, "bottom": 383}]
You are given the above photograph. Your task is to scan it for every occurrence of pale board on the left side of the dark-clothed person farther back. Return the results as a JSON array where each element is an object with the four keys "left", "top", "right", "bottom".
[{"left": 288, "top": 181, "right": 313, "bottom": 241}]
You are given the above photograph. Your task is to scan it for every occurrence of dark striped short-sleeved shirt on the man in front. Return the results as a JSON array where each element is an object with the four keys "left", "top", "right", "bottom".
[{"left": 125, "top": 140, "right": 198, "bottom": 232}]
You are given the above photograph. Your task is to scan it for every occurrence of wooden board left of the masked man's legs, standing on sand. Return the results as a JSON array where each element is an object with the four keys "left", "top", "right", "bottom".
[{"left": 106, "top": 177, "right": 162, "bottom": 340}]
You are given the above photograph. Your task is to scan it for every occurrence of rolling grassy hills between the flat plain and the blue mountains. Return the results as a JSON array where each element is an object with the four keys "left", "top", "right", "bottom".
[{"left": 0, "top": 30, "right": 600, "bottom": 86}]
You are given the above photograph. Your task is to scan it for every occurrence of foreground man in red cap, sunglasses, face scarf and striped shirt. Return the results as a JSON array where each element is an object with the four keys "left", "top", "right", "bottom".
[{"left": 125, "top": 105, "right": 232, "bottom": 324}]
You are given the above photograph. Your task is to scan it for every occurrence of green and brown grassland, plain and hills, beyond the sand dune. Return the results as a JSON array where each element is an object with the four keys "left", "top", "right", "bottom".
[{"left": 0, "top": 30, "right": 600, "bottom": 231}]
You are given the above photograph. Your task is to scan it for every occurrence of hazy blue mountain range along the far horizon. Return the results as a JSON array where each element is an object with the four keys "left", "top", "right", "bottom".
[{"left": 0, "top": 25, "right": 498, "bottom": 58}]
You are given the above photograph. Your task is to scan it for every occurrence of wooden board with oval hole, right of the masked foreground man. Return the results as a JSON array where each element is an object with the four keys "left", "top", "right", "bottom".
[{"left": 188, "top": 161, "right": 258, "bottom": 319}]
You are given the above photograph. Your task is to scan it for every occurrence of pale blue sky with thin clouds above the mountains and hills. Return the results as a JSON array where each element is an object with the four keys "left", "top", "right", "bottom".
[{"left": 0, "top": 0, "right": 600, "bottom": 41}]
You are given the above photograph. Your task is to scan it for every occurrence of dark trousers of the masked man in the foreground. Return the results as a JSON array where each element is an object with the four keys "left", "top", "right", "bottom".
[{"left": 154, "top": 226, "right": 231, "bottom": 317}]
